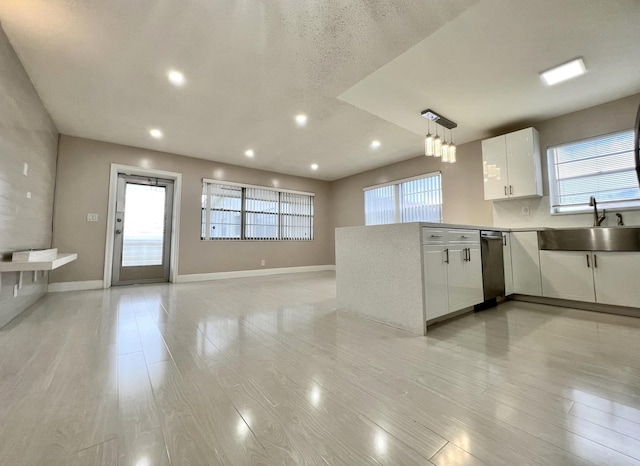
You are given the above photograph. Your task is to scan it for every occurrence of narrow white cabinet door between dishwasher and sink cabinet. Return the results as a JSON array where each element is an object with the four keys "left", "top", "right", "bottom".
[{"left": 511, "top": 231, "right": 542, "bottom": 296}]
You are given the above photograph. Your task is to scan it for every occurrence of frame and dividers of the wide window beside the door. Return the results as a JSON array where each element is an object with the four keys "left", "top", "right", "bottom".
[{"left": 200, "top": 178, "right": 315, "bottom": 242}]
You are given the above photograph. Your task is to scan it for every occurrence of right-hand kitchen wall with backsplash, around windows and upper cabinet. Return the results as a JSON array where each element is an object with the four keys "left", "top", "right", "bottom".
[{"left": 331, "top": 94, "right": 640, "bottom": 258}]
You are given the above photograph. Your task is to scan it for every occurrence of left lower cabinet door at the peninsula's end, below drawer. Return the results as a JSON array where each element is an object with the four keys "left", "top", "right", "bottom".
[{"left": 423, "top": 246, "right": 449, "bottom": 320}]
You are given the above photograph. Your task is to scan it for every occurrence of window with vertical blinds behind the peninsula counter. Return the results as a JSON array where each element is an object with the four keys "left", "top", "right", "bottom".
[{"left": 364, "top": 172, "right": 442, "bottom": 225}]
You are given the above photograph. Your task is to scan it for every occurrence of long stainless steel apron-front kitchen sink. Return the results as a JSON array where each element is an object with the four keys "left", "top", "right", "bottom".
[{"left": 538, "top": 227, "right": 640, "bottom": 251}]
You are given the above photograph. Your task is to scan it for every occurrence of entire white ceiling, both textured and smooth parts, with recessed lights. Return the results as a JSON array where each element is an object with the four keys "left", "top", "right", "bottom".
[{"left": 0, "top": 0, "right": 640, "bottom": 180}]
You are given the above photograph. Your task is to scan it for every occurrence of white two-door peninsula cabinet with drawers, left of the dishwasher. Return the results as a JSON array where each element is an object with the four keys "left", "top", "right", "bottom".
[{"left": 422, "top": 228, "right": 483, "bottom": 320}]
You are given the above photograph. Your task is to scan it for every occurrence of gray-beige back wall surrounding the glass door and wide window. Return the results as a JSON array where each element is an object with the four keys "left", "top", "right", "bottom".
[{"left": 51, "top": 135, "right": 333, "bottom": 283}]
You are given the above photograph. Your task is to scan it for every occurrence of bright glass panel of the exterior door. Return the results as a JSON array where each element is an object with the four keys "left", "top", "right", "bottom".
[{"left": 122, "top": 183, "right": 166, "bottom": 267}]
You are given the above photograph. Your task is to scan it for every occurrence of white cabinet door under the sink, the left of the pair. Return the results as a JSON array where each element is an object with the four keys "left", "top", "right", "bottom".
[{"left": 540, "top": 251, "right": 596, "bottom": 303}]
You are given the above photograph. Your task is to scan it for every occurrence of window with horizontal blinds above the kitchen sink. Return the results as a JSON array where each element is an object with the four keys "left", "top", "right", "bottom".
[{"left": 547, "top": 130, "right": 640, "bottom": 214}]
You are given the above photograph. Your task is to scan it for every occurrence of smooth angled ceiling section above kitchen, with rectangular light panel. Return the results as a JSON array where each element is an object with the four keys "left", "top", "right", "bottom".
[{"left": 339, "top": 0, "right": 640, "bottom": 146}]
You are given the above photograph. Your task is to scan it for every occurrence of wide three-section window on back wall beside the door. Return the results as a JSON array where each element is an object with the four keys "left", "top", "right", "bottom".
[{"left": 201, "top": 180, "right": 314, "bottom": 241}]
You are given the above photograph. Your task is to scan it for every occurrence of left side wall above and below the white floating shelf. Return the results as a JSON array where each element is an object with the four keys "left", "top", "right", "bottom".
[{"left": 0, "top": 23, "right": 58, "bottom": 327}]
